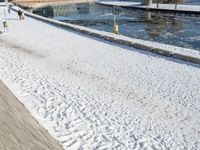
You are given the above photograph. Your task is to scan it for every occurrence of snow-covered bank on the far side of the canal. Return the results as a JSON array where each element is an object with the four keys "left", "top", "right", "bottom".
[{"left": 96, "top": 0, "right": 200, "bottom": 12}]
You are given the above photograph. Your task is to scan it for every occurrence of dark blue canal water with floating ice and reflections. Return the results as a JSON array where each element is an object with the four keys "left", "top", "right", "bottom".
[{"left": 22, "top": 0, "right": 200, "bottom": 51}]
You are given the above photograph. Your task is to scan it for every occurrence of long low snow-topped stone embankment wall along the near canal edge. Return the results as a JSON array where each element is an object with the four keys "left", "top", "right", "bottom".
[{"left": 13, "top": 7, "right": 200, "bottom": 64}]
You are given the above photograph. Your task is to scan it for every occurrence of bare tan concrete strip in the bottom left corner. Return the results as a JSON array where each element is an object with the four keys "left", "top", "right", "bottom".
[{"left": 0, "top": 81, "right": 62, "bottom": 150}]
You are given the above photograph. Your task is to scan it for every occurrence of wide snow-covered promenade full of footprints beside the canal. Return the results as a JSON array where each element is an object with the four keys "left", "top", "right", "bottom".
[{"left": 0, "top": 7, "right": 200, "bottom": 150}]
